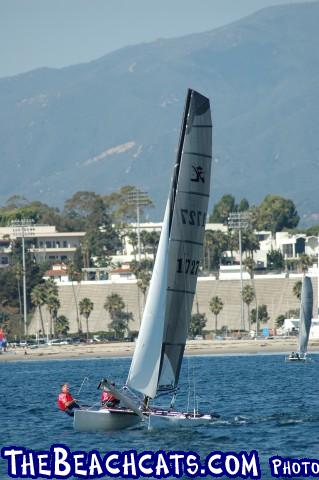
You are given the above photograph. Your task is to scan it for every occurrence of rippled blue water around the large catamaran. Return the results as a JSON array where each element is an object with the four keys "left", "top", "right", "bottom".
[{"left": 0, "top": 355, "right": 319, "bottom": 480}]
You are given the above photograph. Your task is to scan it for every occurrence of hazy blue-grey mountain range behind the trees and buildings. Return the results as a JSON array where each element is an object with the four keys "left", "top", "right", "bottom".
[{"left": 0, "top": 1, "right": 319, "bottom": 224}]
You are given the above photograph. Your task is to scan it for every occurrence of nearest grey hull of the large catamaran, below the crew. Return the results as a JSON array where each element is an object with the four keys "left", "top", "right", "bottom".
[{"left": 74, "top": 408, "right": 141, "bottom": 432}]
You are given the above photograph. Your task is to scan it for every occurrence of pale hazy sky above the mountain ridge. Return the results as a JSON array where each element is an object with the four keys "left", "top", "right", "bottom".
[{"left": 0, "top": 0, "right": 314, "bottom": 77}]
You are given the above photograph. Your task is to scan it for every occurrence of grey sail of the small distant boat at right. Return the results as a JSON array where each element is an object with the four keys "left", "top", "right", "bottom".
[{"left": 299, "top": 276, "right": 313, "bottom": 355}]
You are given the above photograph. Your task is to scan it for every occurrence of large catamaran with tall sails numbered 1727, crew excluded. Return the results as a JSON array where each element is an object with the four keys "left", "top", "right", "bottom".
[{"left": 74, "top": 90, "right": 213, "bottom": 431}]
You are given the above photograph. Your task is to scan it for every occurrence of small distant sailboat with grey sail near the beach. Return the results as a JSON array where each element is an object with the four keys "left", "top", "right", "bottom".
[{"left": 286, "top": 276, "right": 313, "bottom": 362}]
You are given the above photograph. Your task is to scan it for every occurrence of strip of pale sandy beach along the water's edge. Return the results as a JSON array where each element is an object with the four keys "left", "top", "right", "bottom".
[{"left": 0, "top": 337, "right": 319, "bottom": 362}]
